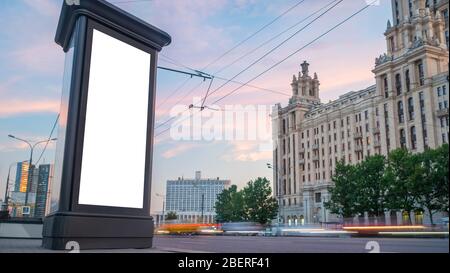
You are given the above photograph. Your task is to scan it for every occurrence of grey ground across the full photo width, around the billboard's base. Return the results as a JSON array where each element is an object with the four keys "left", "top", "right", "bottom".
[{"left": 0, "top": 236, "right": 449, "bottom": 253}]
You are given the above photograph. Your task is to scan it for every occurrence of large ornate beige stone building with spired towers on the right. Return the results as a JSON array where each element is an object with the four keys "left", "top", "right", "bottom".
[{"left": 272, "top": 0, "right": 449, "bottom": 224}]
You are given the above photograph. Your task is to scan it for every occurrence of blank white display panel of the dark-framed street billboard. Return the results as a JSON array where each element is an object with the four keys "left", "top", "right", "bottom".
[{"left": 78, "top": 29, "right": 151, "bottom": 208}]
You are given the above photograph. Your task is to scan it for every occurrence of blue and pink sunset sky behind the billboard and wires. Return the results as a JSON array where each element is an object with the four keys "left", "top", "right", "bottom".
[{"left": 0, "top": 0, "right": 391, "bottom": 211}]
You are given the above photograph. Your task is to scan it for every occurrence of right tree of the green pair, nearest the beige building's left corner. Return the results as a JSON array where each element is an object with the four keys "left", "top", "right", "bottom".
[{"left": 243, "top": 177, "right": 278, "bottom": 224}]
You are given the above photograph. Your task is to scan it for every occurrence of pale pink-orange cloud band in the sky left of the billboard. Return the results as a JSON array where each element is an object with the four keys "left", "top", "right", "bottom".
[{"left": 0, "top": 99, "right": 60, "bottom": 118}]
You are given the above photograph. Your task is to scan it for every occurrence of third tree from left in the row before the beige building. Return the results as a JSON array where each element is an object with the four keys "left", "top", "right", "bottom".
[{"left": 386, "top": 149, "right": 419, "bottom": 224}]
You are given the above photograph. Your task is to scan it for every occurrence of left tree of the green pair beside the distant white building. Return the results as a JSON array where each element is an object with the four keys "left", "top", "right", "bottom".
[{"left": 215, "top": 185, "right": 246, "bottom": 222}]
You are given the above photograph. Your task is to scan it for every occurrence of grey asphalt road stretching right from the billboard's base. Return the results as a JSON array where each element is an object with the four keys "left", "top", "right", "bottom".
[{"left": 154, "top": 235, "right": 449, "bottom": 253}]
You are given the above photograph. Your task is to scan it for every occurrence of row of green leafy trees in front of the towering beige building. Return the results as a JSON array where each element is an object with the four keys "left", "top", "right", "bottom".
[{"left": 325, "top": 145, "right": 449, "bottom": 223}]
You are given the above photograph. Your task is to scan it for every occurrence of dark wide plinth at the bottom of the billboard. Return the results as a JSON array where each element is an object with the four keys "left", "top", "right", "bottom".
[{"left": 42, "top": 213, "right": 154, "bottom": 250}]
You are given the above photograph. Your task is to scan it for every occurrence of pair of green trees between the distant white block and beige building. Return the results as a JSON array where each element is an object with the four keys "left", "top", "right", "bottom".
[{"left": 215, "top": 178, "right": 278, "bottom": 224}]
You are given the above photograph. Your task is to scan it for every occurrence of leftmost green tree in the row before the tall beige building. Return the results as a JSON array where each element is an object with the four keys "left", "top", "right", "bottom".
[{"left": 324, "top": 161, "right": 358, "bottom": 219}]
